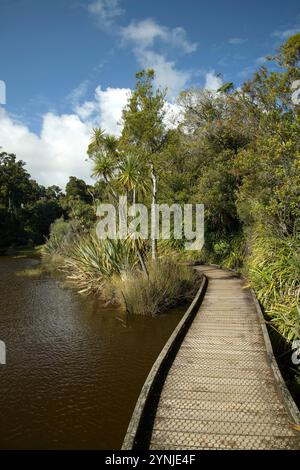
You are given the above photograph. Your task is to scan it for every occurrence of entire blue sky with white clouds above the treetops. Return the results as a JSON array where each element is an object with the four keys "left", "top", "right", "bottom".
[{"left": 0, "top": 0, "right": 300, "bottom": 185}]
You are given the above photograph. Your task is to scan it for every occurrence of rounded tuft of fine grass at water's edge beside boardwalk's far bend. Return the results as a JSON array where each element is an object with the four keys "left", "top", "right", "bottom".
[{"left": 113, "top": 258, "right": 199, "bottom": 315}]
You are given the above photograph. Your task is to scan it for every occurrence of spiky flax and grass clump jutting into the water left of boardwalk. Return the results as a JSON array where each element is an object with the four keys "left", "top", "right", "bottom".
[{"left": 43, "top": 219, "right": 199, "bottom": 315}]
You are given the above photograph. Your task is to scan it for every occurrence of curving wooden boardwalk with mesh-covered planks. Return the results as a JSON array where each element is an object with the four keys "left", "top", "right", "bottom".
[{"left": 144, "top": 267, "right": 300, "bottom": 450}]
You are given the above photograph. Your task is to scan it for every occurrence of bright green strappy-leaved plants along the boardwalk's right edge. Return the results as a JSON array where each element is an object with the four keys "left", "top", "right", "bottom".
[{"left": 246, "top": 225, "right": 300, "bottom": 341}]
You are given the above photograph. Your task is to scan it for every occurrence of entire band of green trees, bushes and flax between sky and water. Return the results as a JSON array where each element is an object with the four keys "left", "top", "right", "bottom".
[{"left": 0, "top": 34, "right": 300, "bottom": 341}]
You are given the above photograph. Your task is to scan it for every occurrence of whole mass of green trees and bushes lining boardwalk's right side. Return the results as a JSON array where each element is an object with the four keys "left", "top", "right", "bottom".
[{"left": 179, "top": 34, "right": 300, "bottom": 340}]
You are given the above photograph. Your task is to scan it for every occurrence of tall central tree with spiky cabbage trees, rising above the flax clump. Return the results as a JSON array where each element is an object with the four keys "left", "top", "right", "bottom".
[{"left": 87, "top": 70, "right": 180, "bottom": 209}]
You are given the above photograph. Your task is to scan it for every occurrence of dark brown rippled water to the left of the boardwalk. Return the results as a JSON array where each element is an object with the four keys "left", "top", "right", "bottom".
[{"left": 0, "top": 257, "right": 184, "bottom": 449}]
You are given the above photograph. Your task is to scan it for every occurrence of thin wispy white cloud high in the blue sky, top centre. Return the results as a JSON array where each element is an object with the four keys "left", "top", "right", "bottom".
[{"left": 121, "top": 18, "right": 197, "bottom": 53}]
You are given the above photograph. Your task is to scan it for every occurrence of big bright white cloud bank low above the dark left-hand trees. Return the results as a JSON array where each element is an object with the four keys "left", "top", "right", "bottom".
[{"left": 0, "top": 87, "right": 130, "bottom": 187}]
